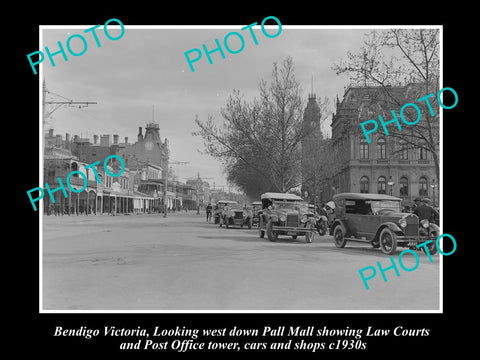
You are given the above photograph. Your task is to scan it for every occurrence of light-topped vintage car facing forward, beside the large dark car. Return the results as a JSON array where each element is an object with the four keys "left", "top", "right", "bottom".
[{"left": 258, "top": 192, "right": 316, "bottom": 243}]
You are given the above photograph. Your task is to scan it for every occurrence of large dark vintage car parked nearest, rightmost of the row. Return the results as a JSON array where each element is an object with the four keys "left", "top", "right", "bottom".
[{"left": 330, "top": 193, "right": 440, "bottom": 255}]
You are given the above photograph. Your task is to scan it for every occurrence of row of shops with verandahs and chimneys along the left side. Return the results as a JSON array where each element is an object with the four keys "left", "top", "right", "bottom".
[{"left": 43, "top": 123, "right": 203, "bottom": 215}]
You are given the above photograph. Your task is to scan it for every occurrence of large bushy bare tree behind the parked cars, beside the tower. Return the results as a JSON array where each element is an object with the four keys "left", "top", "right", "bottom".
[{"left": 194, "top": 57, "right": 304, "bottom": 196}]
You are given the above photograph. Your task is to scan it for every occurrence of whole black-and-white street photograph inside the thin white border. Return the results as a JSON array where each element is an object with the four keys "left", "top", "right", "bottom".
[{"left": 39, "top": 24, "right": 442, "bottom": 311}]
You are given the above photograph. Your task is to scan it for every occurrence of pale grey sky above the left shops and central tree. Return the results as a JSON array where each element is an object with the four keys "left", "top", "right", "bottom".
[{"left": 39, "top": 21, "right": 371, "bottom": 187}]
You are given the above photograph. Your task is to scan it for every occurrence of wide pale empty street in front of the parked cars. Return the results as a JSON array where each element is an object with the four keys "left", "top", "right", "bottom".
[{"left": 41, "top": 212, "right": 440, "bottom": 311}]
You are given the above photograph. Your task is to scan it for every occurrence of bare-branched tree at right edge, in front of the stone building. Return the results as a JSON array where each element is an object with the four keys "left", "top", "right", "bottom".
[{"left": 333, "top": 28, "right": 440, "bottom": 183}]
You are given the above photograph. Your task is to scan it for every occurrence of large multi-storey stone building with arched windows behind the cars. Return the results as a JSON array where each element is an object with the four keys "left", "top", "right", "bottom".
[{"left": 321, "top": 84, "right": 439, "bottom": 206}]
